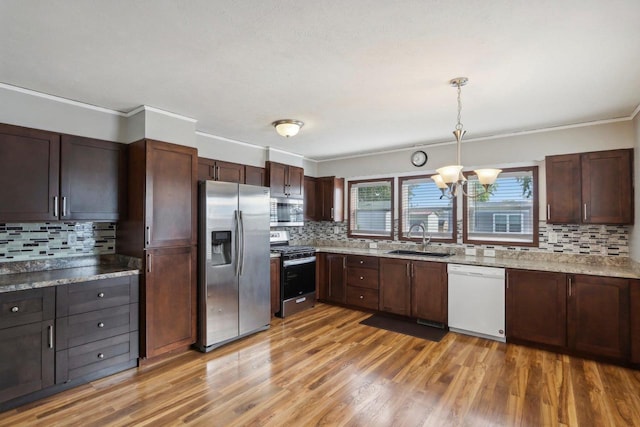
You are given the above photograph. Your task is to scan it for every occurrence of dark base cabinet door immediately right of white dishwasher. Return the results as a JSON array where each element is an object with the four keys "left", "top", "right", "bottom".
[{"left": 506, "top": 270, "right": 567, "bottom": 347}]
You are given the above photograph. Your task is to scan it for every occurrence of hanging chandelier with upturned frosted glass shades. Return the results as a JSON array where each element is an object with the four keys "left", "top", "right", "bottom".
[{"left": 431, "top": 77, "right": 502, "bottom": 198}]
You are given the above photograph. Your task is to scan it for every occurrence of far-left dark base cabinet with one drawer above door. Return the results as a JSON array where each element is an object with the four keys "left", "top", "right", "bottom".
[{"left": 0, "top": 288, "right": 55, "bottom": 403}]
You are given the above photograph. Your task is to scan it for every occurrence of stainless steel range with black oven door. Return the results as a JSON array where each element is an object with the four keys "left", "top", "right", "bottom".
[{"left": 270, "top": 231, "right": 316, "bottom": 317}]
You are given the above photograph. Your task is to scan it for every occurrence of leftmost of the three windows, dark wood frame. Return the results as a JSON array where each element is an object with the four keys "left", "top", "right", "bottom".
[{"left": 348, "top": 178, "right": 393, "bottom": 239}]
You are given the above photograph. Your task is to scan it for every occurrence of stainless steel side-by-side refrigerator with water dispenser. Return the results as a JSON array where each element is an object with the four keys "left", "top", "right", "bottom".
[{"left": 197, "top": 181, "right": 271, "bottom": 352}]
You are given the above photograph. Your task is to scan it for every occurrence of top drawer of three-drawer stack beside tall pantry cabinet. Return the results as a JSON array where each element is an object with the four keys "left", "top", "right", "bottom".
[{"left": 56, "top": 276, "right": 138, "bottom": 317}]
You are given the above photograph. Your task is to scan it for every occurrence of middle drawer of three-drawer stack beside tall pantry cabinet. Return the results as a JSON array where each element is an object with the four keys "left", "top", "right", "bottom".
[{"left": 56, "top": 303, "right": 138, "bottom": 350}]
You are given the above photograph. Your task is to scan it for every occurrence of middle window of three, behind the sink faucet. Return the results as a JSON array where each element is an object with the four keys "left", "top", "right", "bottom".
[{"left": 399, "top": 175, "right": 456, "bottom": 242}]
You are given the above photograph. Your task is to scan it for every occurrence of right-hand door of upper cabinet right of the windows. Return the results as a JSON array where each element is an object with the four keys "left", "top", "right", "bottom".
[{"left": 584, "top": 150, "right": 633, "bottom": 224}]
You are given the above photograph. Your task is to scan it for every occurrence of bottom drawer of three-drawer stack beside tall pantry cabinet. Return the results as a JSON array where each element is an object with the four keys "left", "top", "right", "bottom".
[{"left": 56, "top": 332, "right": 138, "bottom": 384}]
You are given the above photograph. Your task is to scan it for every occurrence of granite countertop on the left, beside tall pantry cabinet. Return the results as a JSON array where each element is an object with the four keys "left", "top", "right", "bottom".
[{"left": 0, "top": 257, "right": 140, "bottom": 293}]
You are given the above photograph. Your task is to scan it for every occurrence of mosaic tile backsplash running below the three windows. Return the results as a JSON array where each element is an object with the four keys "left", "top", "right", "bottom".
[{"left": 286, "top": 220, "right": 631, "bottom": 257}]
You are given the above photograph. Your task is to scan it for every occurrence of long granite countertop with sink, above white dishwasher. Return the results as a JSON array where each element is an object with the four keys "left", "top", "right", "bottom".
[{"left": 316, "top": 246, "right": 640, "bottom": 279}]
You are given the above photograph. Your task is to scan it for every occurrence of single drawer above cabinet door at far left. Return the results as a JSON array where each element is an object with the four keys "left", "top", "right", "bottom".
[{"left": 0, "top": 287, "right": 55, "bottom": 329}]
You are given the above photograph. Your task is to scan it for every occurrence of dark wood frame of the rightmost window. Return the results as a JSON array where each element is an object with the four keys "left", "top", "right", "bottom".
[{"left": 462, "top": 166, "right": 540, "bottom": 247}]
